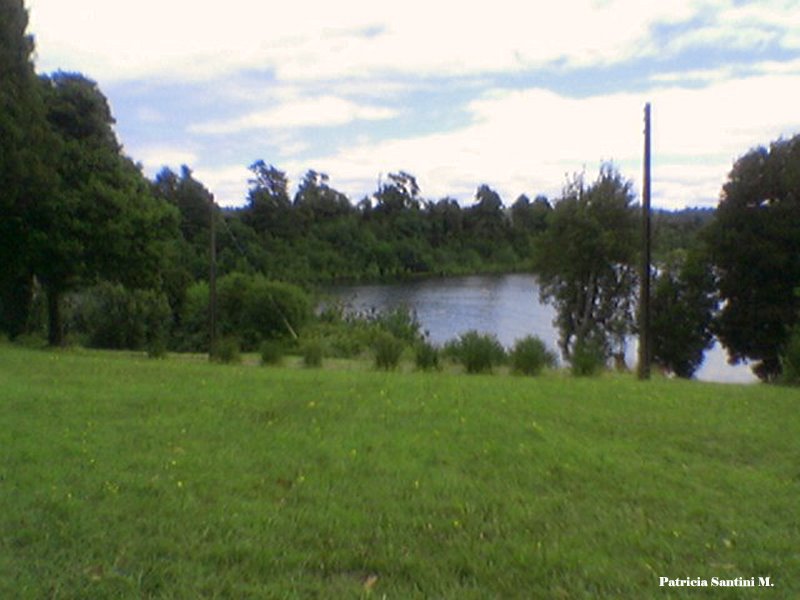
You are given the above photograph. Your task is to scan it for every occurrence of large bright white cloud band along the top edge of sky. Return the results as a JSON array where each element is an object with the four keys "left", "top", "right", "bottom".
[{"left": 29, "top": 0, "right": 708, "bottom": 82}]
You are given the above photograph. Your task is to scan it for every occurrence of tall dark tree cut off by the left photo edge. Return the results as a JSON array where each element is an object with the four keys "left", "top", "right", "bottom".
[{"left": 0, "top": 0, "right": 54, "bottom": 337}]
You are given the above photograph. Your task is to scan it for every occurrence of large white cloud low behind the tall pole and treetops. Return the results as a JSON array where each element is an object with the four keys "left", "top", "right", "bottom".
[{"left": 266, "top": 76, "right": 800, "bottom": 208}]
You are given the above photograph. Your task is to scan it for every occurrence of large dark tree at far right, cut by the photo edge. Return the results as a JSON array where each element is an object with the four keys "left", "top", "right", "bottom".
[{"left": 707, "top": 135, "right": 800, "bottom": 380}]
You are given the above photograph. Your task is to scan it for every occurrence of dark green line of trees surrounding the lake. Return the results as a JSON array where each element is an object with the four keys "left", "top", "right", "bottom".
[{"left": 0, "top": 0, "right": 800, "bottom": 380}]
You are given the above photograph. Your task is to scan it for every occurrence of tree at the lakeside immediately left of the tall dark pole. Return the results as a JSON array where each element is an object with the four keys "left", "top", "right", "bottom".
[{"left": 534, "top": 165, "right": 638, "bottom": 360}]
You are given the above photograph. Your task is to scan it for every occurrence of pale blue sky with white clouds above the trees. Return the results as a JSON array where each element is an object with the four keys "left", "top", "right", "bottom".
[{"left": 21, "top": 0, "right": 800, "bottom": 209}]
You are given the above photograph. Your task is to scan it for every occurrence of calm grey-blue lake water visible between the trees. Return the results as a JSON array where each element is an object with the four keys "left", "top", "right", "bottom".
[{"left": 326, "top": 275, "right": 756, "bottom": 383}]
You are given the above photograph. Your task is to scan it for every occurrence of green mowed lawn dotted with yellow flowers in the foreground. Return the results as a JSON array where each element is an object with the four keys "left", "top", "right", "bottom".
[{"left": 0, "top": 345, "right": 800, "bottom": 599}]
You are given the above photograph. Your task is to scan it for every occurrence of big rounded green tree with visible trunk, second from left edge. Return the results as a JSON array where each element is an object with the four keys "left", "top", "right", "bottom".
[{"left": 32, "top": 72, "right": 177, "bottom": 345}]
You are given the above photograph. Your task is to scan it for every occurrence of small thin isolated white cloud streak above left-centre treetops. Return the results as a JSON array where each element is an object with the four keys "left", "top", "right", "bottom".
[{"left": 189, "top": 96, "right": 397, "bottom": 134}]
